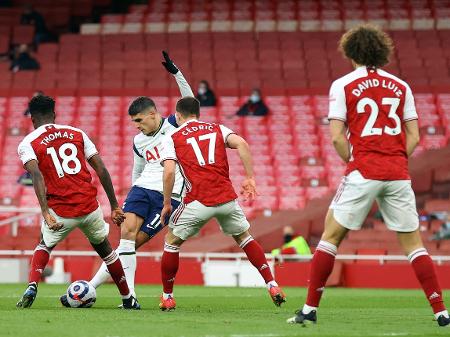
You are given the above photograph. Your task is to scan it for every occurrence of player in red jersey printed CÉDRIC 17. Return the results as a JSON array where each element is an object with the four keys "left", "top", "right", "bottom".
[{"left": 159, "top": 97, "right": 285, "bottom": 310}]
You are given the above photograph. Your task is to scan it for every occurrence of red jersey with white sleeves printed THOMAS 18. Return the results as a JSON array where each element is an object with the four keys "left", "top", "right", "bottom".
[{"left": 18, "top": 124, "right": 98, "bottom": 218}]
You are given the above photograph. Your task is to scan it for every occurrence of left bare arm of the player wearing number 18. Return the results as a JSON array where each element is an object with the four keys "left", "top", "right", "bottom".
[{"left": 24, "top": 160, "right": 63, "bottom": 231}]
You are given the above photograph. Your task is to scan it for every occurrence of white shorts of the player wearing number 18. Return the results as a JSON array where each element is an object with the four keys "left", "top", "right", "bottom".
[{"left": 41, "top": 207, "right": 109, "bottom": 247}]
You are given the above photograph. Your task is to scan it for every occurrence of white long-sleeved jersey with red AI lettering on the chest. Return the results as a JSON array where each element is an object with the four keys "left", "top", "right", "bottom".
[{"left": 132, "top": 115, "right": 184, "bottom": 199}]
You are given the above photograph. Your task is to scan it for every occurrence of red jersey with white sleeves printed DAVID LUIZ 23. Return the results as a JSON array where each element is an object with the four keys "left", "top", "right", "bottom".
[{"left": 328, "top": 67, "right": 417, "bottom": 180}]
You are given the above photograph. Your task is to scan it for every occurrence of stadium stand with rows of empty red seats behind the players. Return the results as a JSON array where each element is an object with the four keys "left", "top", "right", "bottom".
[{"left": 0, "top": 0, "right": 450, "bottom": 254}]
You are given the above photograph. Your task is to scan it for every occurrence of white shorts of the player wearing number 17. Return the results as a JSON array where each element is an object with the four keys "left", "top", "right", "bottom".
[{"left": 169, "top": 200, "right": 250, "bottom": 241}]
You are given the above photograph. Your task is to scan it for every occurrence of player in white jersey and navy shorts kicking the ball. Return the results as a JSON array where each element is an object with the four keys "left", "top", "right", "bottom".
[{"left": 61, "top": 52, "right": 194, "bottom": 306}]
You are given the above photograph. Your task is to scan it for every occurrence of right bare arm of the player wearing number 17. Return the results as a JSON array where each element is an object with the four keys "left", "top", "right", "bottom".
[{"left": 225, "top": 131, "right": 257, "bottom": 201}]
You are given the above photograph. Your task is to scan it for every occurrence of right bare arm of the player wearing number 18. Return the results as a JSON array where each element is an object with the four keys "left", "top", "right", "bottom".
[{"left": 88, "top": 154, "right": 125, "bottom": 225}]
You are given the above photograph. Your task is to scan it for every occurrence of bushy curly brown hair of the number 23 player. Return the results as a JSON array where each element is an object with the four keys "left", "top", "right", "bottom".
[{"left": 339, "top": 24, "right": 394, "bottom": 68}]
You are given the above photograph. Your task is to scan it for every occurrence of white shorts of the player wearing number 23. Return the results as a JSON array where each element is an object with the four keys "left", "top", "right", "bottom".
[{"left": 330, "top": 171, "right": 419, "bottom": 232}]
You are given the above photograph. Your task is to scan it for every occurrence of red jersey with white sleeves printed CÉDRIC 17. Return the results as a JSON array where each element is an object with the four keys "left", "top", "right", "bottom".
[{"left": 161, "top": 120, "right": 237, "bottom": 206}]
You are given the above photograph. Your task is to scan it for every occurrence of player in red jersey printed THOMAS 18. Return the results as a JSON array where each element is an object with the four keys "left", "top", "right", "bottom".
[{"left": 17, "top": 96, "right": 140, "bottom": 309}]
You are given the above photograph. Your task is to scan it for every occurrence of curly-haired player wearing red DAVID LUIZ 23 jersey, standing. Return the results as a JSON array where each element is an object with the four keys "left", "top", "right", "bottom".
[{"left": 288, "top": 25, "right": 450, "bottom": 326}]
